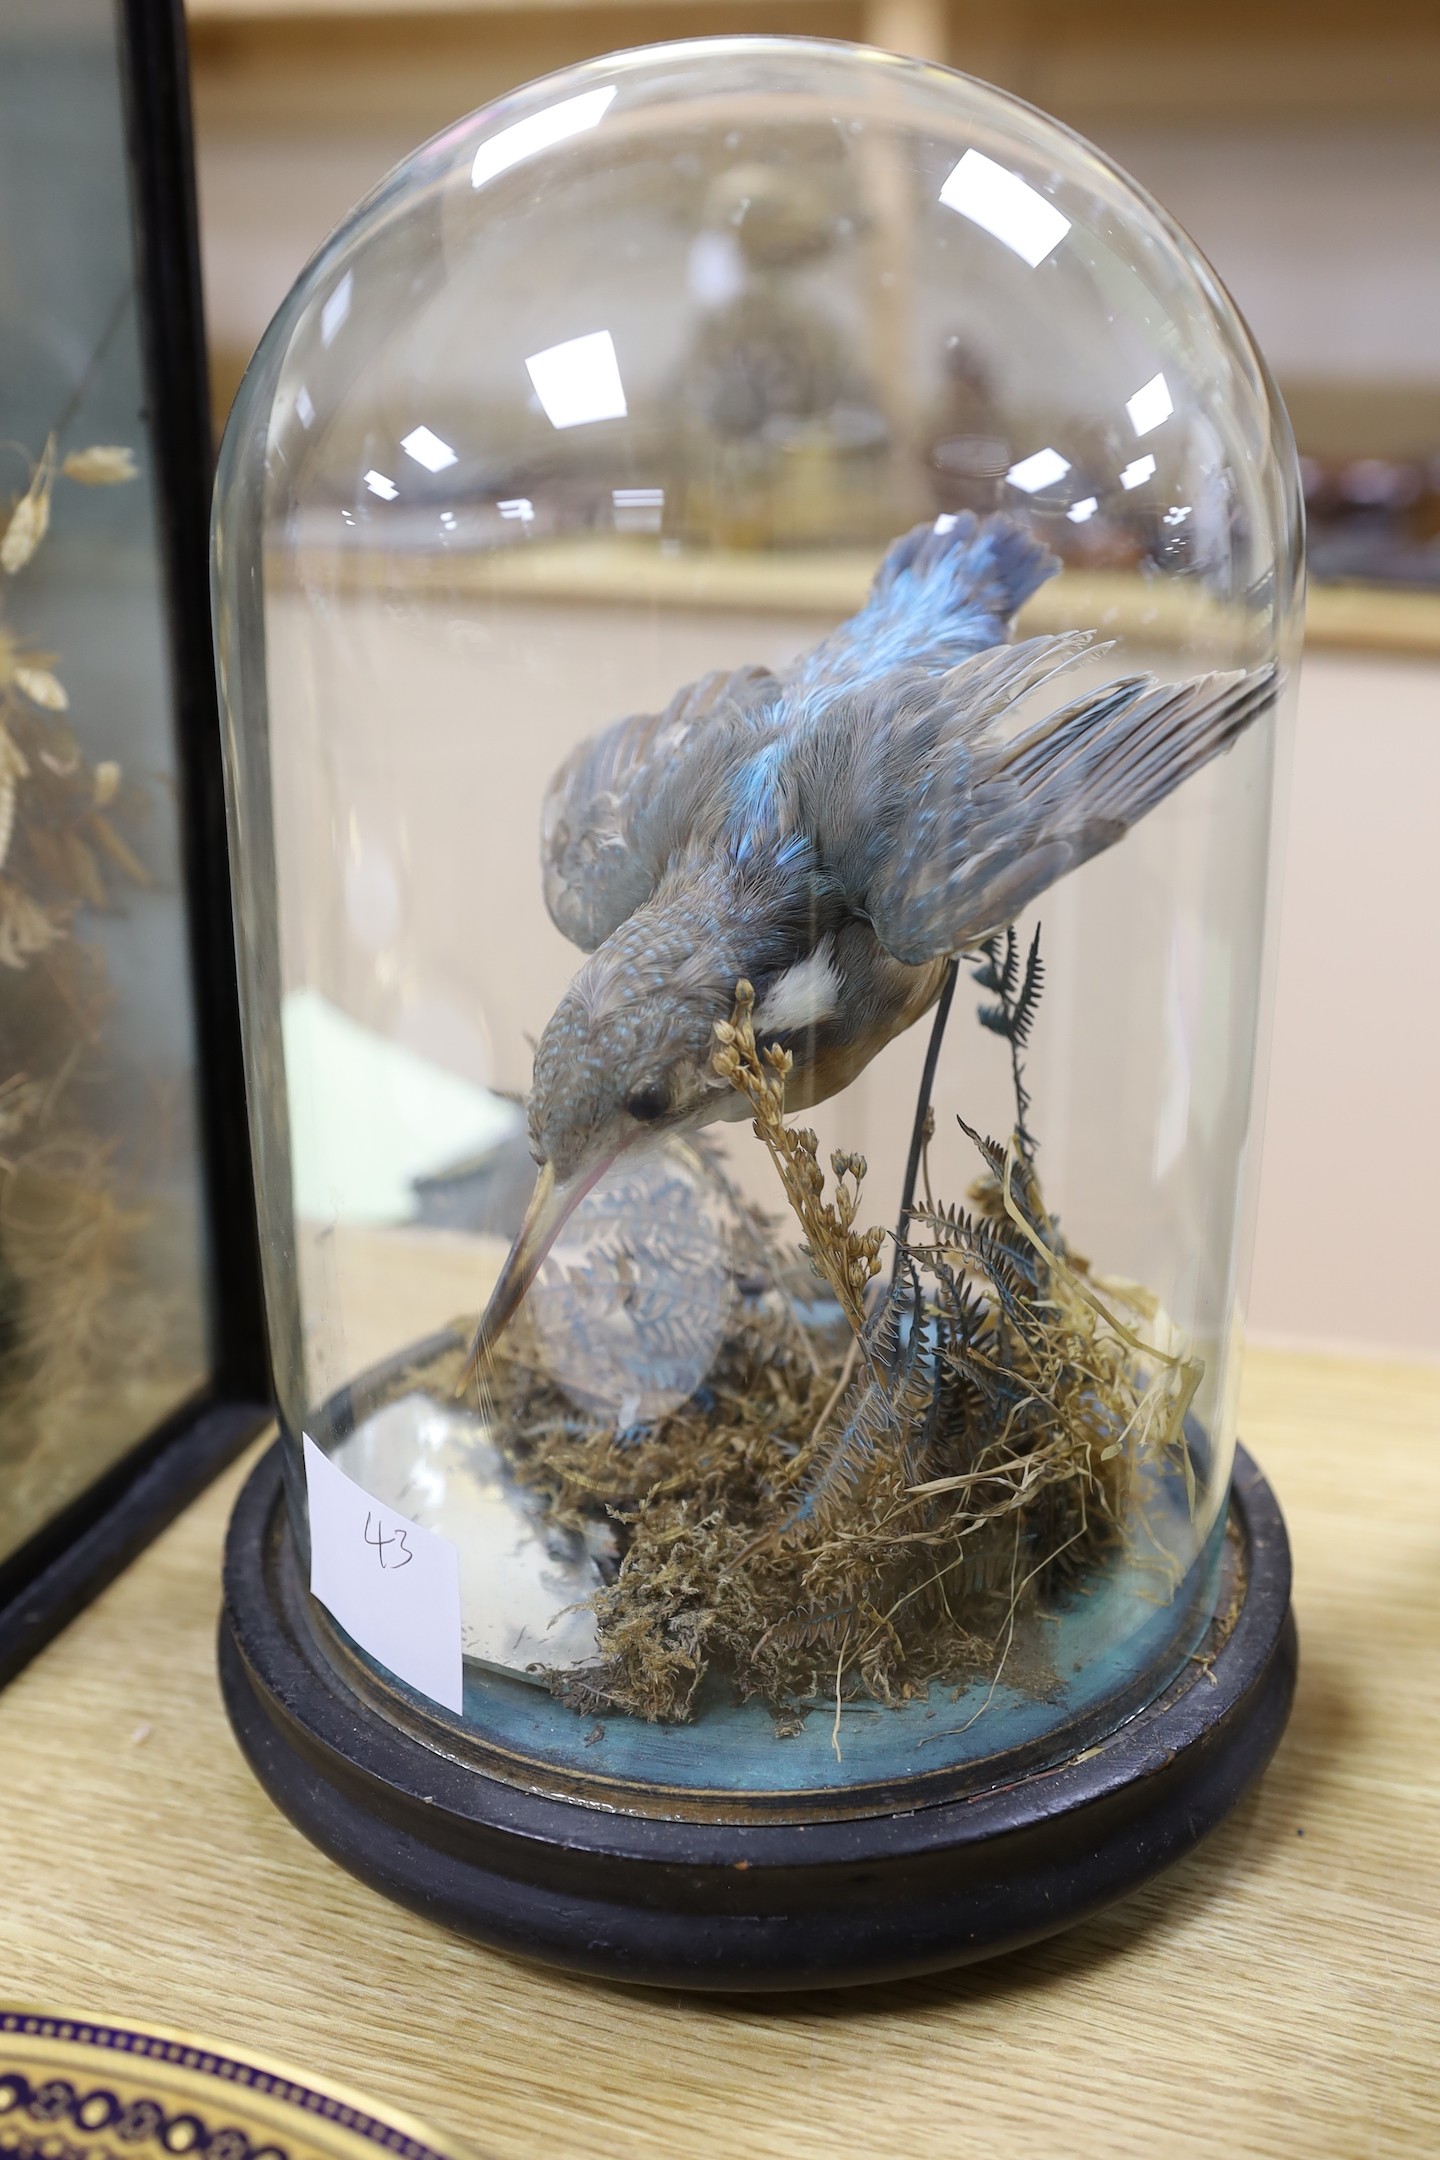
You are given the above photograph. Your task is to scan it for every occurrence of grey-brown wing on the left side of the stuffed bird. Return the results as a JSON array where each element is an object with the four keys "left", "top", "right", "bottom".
[{"left": 540, "top": 667, "right": 779, "bottom": 953}]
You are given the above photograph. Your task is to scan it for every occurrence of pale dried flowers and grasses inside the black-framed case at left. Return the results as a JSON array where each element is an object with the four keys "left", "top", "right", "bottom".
[{"left": 0, "top": 421, "right": 171, "bottom": 1557}]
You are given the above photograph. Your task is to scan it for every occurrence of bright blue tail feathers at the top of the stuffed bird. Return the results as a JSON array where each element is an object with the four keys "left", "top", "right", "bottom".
[{"left": 786, "top": 510, "right": 1060, "bottom": 702}]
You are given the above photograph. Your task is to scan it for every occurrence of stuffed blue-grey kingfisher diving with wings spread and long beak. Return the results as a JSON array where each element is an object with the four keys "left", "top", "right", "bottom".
[{"left": 466, "top": 514, "right": 1274, "bottom": 1378}]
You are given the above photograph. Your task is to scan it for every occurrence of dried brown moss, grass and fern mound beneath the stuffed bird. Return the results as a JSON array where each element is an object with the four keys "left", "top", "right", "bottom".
[{"left": 432, "top": 931, "right": 1200, "bottom": 1730}]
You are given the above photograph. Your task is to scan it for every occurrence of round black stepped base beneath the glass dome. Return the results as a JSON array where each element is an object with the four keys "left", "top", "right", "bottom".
[{"left": 220, "top": 1449, "right": 1295, "bottom": 1989}]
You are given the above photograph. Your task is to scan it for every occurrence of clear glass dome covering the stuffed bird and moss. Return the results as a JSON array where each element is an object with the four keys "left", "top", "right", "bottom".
[{"left": 216, "top": 39, "right": 1300, "bottom": 1817}]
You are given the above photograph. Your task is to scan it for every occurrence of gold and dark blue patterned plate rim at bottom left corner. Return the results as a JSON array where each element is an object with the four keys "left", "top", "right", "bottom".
[{"left": 0, "top": 2009, "right": 472, "bottom": 2160}]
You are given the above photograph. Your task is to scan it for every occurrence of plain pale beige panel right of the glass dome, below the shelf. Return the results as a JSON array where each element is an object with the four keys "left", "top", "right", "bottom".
[{"left": 1250, "top": 650, "right": 1440, "bottom": 1356}]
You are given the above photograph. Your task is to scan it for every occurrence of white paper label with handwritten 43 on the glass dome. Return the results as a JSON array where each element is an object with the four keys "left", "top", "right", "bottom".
[{"left": 302, "top": 1432, "right": 462, "bottom": 1713}]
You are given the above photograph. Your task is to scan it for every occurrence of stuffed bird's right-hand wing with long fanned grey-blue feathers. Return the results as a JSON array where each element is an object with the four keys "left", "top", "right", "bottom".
[{"left": 827, "top": 635, "right": 1276, "bottom": 966}]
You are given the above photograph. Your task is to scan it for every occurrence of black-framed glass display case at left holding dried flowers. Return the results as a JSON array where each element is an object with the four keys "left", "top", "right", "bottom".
[{"left": 0, "top": 0, "right": 268, "bottom": 1678}]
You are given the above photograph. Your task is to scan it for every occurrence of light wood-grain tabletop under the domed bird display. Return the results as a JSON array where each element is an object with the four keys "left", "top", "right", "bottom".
[{"left": 0, "top": 1352, "right": 1440, "bottom": 2160}]
